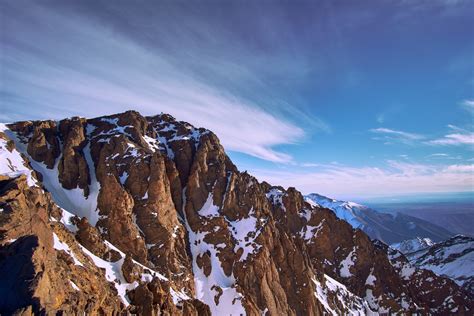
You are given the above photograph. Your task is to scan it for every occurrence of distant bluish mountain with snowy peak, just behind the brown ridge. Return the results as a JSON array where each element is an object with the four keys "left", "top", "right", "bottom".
[{"left": 305, "top": 193, "right": 454, "bottom": 244}]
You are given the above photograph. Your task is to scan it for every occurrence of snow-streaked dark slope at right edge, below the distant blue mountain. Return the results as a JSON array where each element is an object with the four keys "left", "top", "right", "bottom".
[{"left": 391, "top": 235, "right": 474, "bottom": 292}]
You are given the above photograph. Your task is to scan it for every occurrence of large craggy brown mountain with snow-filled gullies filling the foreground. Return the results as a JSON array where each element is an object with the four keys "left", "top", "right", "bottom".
[{"left": 0, "top": 111, "right": 473, "bottom": 315}]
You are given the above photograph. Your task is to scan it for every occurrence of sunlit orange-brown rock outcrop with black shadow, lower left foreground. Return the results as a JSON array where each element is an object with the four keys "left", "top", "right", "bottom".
[{"left": 0, "top": 176, "right": 123, "bottom": 314}]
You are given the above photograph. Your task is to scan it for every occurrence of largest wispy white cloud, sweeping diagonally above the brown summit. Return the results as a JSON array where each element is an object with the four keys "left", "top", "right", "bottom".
[{"left": 0, "top": 4, "right": 314, "bottom": 163}]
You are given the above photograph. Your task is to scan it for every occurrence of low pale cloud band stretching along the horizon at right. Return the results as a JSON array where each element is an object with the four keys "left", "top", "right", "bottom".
[{"left": 251, "top": 160, "right": 474, "bottom": 198}]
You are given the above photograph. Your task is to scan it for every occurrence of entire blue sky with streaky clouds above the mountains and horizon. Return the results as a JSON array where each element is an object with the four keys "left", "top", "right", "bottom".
[{"left": 0, "top": 0, "right": 474, "bottom": 201}]
